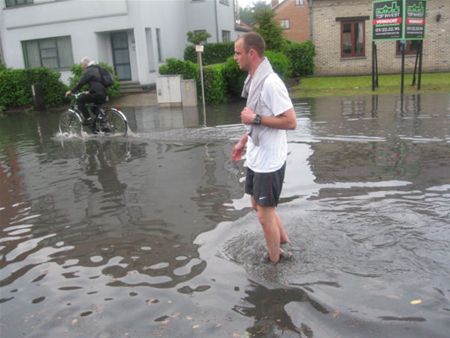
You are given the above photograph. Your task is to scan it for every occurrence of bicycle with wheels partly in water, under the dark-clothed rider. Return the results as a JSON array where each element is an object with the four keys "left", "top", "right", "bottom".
[{"left": 59, "top": 93, "right": 128, "bottom": 136}]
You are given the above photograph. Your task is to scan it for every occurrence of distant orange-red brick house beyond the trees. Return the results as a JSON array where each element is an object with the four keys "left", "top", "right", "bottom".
[{"left": 272, "top": 0, "right": 311, "bottom": 42}]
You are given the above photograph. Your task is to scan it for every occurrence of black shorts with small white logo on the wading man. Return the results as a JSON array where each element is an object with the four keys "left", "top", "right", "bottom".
[{"left": 245, "top": 163, "right": 286, "bottom": 207}]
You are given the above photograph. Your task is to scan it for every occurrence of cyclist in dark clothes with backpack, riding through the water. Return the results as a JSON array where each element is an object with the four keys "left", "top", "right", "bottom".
[{"left": 66, "top": 56, "right": 107, "bottom": 125}]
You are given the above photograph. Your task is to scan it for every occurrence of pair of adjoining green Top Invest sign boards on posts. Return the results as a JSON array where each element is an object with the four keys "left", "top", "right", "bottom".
[{"left": 372, "top": 0, "right": 426, "bottom": 40}]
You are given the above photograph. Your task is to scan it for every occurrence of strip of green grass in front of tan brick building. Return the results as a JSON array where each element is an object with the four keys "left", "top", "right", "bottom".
[{"left": 289, "top": 73, "right": 450, "bottom": 99}]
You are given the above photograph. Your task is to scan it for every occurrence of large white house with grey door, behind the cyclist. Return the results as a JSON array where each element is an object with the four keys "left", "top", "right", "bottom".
[{"left": 0, "top": 0, "right": 237, "bottom": 85}]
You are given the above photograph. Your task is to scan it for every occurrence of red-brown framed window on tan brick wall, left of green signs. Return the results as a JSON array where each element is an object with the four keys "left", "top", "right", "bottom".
[{"left": 341, "top": 21, "right": 365, "bottom": 57}]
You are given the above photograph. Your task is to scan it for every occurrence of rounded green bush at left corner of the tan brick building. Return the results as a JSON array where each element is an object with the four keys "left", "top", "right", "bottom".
[{"left": 285, "top": 41, "right": 316, "bottom": 77}]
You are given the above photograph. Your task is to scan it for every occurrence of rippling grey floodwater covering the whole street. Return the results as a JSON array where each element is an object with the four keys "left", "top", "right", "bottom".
[{"left": 0, "top": 94, "right": 450, "bottom": 338}]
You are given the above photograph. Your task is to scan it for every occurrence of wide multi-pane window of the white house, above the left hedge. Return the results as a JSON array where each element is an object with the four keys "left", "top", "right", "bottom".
[{"left": 22, "top": 36, "right": 73, "bottom": 70}]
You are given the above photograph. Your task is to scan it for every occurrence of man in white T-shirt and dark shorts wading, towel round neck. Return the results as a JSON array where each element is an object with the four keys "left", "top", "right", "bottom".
[{"left": 231, "top": 32, "right": 297, "bottom": 263}]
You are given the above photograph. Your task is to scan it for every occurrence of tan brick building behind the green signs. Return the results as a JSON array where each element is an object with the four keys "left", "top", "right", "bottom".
[{"left": 309, "top": 0, "right": 450, "bottom": 75}]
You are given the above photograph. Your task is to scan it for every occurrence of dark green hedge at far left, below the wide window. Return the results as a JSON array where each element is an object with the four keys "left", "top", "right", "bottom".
[{"left": 0, "top": 68, "right": 67, "bottom": 109}]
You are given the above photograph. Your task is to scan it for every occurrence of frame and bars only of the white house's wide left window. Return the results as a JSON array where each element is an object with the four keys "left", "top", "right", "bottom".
[{"left": 21, "top": 35, "right": 74, "bottom": 71}]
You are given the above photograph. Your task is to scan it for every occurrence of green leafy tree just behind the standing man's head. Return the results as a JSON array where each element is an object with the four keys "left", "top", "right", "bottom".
[{"left": 255, "top": 8, "right": 286, "bottom": 52}]
